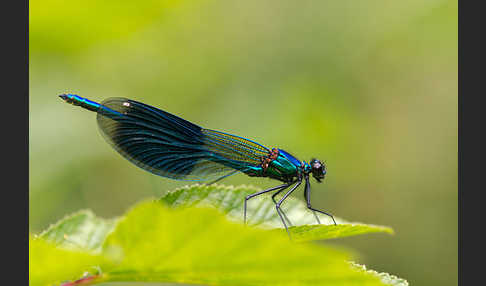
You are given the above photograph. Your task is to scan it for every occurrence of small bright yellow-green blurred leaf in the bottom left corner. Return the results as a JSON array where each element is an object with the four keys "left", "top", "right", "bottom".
[{"left": 29, "top": 236, "right": 109, "bottom": 286}]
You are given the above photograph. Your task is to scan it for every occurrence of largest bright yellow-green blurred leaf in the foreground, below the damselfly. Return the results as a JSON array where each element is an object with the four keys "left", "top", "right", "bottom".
[{"left": 99, "top": 202, "right": 388, "bottom": 286}]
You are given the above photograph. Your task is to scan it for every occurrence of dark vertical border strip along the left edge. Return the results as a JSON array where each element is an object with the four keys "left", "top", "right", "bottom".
[{"left": 0, "top": 0, "right": 29, "bottom": 285}]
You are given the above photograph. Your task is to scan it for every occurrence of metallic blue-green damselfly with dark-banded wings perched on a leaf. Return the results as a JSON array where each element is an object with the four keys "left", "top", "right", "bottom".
[{"left": 60, "top": 94, "right": 336, "bottom": 235}]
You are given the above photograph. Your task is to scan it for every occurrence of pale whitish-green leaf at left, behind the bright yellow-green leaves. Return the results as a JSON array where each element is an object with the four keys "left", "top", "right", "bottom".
[{"left": 39, "top": 210, "right": 117, "bottom": 253}]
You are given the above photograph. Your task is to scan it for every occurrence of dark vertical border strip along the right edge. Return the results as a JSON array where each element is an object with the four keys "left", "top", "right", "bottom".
[{"left": 458, "top": 1, "right": 480, "bottom": 285}]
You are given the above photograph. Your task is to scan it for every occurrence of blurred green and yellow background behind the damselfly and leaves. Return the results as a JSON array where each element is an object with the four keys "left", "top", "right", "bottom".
[{"left": 29, "top": 0, "right": 458, "bottom": 285}]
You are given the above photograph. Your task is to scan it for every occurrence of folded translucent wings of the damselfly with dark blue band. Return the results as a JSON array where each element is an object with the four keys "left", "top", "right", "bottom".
[{"left": 97, "top": 98, "right": 268, "bottom": 181}]
